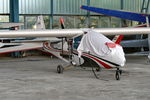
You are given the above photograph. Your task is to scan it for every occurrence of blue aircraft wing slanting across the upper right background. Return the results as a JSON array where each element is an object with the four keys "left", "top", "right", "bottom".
[{"left": 81, "top": 6, "right": 150, "bottom": 23}]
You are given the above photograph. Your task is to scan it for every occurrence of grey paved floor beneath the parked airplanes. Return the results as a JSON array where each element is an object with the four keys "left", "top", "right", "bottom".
[{"left": 0, "top": 56, "right": 150, "bottom": 100}]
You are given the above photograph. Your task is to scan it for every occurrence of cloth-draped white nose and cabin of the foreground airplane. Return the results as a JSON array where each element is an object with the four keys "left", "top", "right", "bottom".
[{"left": 77, "top": 31, "right": 126, "bottom": 69}]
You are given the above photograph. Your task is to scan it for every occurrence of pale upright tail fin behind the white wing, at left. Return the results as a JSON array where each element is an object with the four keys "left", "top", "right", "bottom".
[{"left": 35, "top": 15, "right": 45, "bottom": 29}]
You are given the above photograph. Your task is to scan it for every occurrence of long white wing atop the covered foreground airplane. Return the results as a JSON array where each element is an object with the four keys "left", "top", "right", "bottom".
[{"left": 0, "top": 27, "right": 150, "bottom": 38}]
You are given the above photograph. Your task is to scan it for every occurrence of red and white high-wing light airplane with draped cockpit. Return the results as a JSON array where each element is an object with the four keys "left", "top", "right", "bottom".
[{"left": 0, "top": 16, "right": 150, "bottom": 80}]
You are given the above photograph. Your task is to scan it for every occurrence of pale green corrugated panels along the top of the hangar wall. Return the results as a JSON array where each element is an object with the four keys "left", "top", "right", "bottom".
[{"left": 0, "top": 0, "right": 150, "bottom": 14}]
